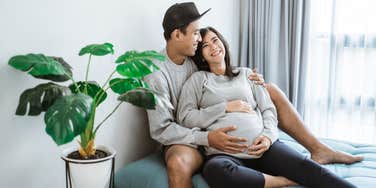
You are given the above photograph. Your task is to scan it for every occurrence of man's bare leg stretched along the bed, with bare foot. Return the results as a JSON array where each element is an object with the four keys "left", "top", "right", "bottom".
[{"left": 267, "top": 84, "right": 363, "bottom": 164}]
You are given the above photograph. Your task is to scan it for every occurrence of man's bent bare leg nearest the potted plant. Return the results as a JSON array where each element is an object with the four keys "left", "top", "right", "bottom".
[{"left": 165, "top": 145, "right": 204, "bottom": 188}]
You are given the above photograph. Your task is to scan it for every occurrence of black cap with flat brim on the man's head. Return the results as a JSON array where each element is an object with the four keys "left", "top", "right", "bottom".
[{"left": 162, "top": 2, "right": 210, "bottom": 34}]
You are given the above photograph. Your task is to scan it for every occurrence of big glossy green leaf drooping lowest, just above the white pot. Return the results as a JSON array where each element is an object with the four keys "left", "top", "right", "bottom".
[{"left": 44, "top": 94, "right": 94, "bottom": 145}]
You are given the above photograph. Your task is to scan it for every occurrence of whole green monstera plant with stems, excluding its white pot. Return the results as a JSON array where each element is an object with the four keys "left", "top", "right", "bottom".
[{"left": 8, "top": 43, "right": 169, "bottom": 159}]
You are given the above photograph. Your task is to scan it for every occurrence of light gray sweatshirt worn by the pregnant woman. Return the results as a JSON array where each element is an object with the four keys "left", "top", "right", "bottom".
[{"left": 178, "top": 68, "right": 278, "bottom": 158}]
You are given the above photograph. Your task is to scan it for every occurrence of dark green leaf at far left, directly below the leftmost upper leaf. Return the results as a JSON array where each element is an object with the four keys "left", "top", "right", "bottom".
[{"left": 16, "top": 82, "right": 71, "bottom": 116}]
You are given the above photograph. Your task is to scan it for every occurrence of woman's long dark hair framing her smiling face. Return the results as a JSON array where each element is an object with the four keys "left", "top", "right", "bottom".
[{"left": 192, "top": 27, "right": 238, "bottom": 78}]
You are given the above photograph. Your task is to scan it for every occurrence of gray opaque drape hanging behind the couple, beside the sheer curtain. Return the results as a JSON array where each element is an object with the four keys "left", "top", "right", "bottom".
[{"left": 238, "top": 0, "right": 310, "bottom": 113}]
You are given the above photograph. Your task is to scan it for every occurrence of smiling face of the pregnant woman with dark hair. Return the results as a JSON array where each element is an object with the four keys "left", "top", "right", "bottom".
[{"left": 202, "top": 31, "right": 226, "bottom": 65}]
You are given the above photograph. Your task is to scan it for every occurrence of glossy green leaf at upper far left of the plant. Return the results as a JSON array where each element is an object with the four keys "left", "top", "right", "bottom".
[{"left": 8, "top": 54, "right": 72, "bottom": 82}]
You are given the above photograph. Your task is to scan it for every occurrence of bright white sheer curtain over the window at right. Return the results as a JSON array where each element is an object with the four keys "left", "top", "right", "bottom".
[{"left": 304, "top": 0, "right": 376, "bottom": 144}]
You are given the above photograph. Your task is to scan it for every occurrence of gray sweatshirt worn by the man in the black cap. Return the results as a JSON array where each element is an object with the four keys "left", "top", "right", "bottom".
[{"left": 144, "top": 50, "right": 208, "bottom": 147}]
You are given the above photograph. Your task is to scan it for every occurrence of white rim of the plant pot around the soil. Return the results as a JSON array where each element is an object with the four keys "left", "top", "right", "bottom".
[{"left": 61, "top": 145, "right": 116, "bottom": 164}]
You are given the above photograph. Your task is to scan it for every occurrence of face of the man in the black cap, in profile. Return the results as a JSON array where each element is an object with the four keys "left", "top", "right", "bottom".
[{"left": 181, "top": 20, "right": 201, "bottom": 56}]
